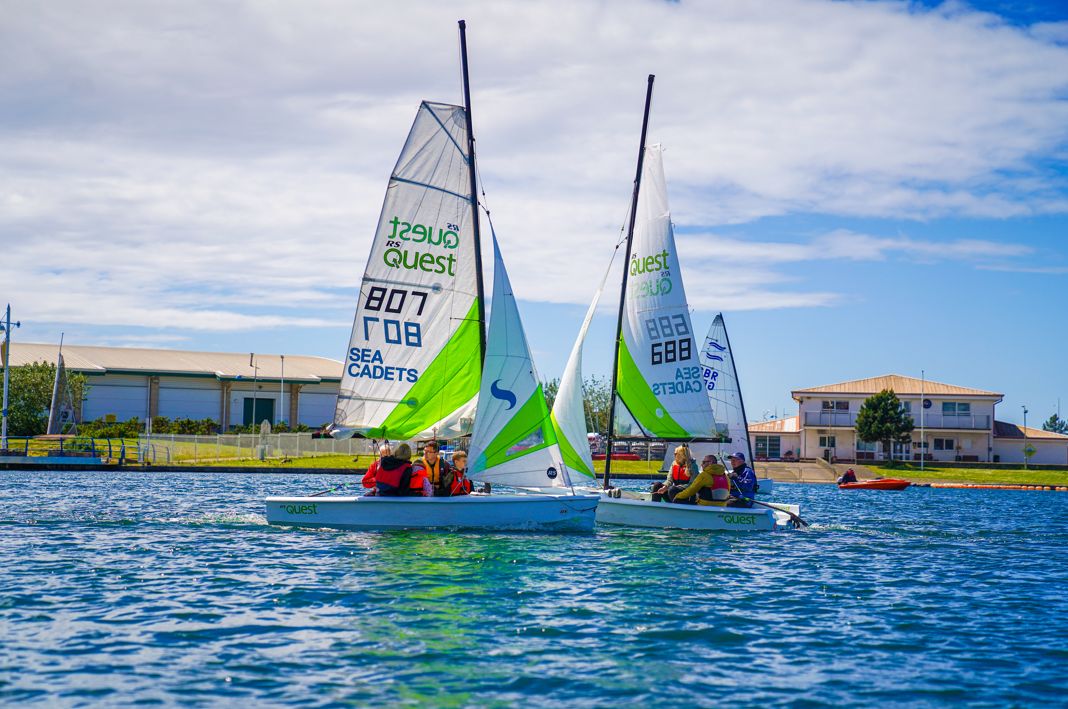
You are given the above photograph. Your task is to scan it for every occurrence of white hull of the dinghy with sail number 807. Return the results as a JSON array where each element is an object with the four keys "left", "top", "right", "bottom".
[{"left": 266, "top": 494, "right": 598, "bottom": 532}]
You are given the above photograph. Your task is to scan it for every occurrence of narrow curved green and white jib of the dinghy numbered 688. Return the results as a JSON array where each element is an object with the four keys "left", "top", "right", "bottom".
[{"left": 552, "top": 253, "right": 615, "bottom": 477}]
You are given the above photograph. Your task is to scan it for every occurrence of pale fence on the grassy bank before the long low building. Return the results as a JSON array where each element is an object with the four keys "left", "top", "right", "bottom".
[{"left": 138, "top": 434, "right": 386, "bottom": 464}]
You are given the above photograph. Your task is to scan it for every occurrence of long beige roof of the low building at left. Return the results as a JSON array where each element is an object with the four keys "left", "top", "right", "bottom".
[{"left": 1, "top": 342, "right": 342, "bottom": 383}]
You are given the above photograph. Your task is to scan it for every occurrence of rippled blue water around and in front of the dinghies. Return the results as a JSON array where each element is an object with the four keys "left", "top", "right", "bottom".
[{"left": 0, "top": 472, "right": 1068, "bottom": 707}]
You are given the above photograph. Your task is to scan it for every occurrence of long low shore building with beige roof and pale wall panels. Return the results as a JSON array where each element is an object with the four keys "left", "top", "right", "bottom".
[{"left": 11, "top": 342, "right": 342, "bottom": 430}]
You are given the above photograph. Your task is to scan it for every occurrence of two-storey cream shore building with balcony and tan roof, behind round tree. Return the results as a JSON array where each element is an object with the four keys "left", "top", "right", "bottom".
[{"left": 749, "top": 374, "right": 1068, "bottom": 466}]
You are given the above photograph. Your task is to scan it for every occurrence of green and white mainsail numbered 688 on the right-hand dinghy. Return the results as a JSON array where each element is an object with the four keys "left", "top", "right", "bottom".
[{"left": 615, "top": 145, "right": 714, "bottom": 440}]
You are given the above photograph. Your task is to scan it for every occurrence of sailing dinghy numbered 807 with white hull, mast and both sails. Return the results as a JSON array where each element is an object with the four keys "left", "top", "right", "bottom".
[{"left": 266, "top": 21, "right": 598, "bottom": 531}]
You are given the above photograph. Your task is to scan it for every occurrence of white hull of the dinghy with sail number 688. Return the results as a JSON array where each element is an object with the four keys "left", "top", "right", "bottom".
[{"left": 597, "top": 497, "right": 788, "bottom": 532}]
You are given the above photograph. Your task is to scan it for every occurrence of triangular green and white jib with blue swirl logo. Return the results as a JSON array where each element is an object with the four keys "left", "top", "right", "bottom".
[{"left": 469, "top": 229, "right": 570, "bottom": 488}]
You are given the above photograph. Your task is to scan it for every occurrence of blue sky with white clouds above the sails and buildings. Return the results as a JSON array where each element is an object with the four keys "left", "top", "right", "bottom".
[{"left": 0, "top": 0, "right": 1068, "bottom": 425}]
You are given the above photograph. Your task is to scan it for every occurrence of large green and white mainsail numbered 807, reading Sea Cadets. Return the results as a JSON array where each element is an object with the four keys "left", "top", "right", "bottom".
[{"left": 333, "top": 101, "right": 481, "bottom": 439}]
